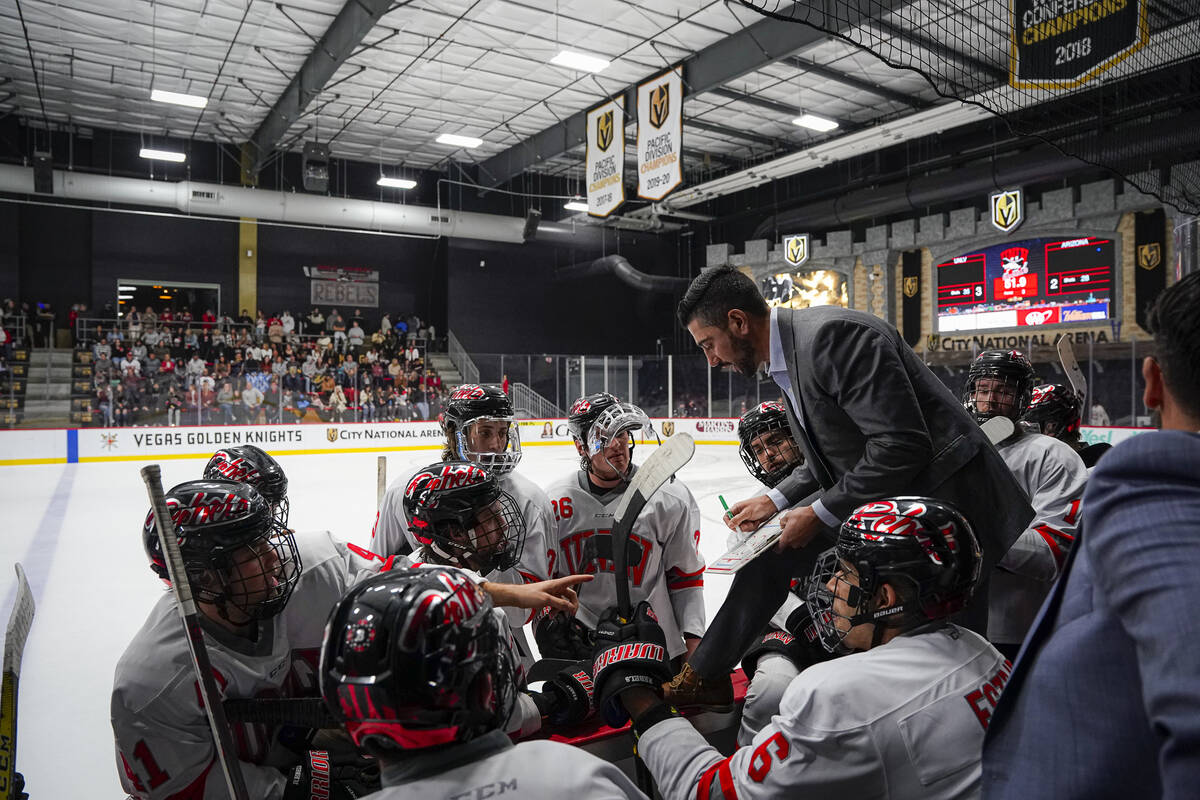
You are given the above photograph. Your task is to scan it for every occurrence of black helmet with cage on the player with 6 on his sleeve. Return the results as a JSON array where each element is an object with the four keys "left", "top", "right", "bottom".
[{"left": 808, "top": 497, "right": 983, "bottom": 652}]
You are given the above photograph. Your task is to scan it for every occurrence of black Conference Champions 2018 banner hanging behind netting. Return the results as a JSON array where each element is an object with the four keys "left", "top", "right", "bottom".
[{"left": 1008, "top": 0, "right": 1150, "bottom": 89}]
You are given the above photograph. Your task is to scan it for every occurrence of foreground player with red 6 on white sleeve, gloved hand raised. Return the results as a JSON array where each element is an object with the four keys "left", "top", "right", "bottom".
[{"left": 594, "top": 498, "right": 1010, "bottom": 800}]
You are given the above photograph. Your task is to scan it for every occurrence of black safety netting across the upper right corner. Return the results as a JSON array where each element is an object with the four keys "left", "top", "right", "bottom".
[{"left": 739, "top": 0, "right": 1200, "bottom": 215}]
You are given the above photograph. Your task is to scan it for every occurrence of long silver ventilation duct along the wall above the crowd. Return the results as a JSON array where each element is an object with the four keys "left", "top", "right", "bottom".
[{"left": 0, "top": 164, "right": 602, "bottom": 243}]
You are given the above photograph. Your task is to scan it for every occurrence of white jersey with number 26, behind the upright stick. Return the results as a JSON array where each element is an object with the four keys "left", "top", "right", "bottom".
[{"left": 546, "top": 470, "right": 706, "bottom": 658}]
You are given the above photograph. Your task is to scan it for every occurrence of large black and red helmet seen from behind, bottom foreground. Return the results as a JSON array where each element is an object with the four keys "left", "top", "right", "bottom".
[{"left": 320, "top": 566, "right": 516, "bottom": 756}]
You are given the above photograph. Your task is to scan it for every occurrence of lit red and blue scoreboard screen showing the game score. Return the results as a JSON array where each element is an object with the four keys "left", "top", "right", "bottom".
[{"left": 936, "top": 236, "right": 1116, "bottom": 333}]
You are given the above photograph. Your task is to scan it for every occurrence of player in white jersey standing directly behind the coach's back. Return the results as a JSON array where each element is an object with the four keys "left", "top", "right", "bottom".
[{"left": 962, "top": 350, "right": 1087, "bottom": 658}]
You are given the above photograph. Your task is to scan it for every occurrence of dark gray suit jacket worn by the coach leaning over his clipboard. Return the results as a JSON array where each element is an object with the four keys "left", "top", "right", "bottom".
[{"left": 778, "top": 306, "right": 1033, "bottom": 576}]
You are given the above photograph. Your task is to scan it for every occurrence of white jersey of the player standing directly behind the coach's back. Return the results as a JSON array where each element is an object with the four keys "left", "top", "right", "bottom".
[{"left": 988, "top": 433, "right": 1087, "bottom": 644}]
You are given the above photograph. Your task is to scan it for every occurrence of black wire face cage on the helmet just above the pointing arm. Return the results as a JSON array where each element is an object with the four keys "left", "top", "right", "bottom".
[{"left": 412, "top": 492, "right": 526, "bottom": 575}]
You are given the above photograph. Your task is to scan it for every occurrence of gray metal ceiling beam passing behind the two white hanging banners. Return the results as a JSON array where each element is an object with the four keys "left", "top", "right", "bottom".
[{"left": 470, "top": 0, "right": 905, "bottom": 187}]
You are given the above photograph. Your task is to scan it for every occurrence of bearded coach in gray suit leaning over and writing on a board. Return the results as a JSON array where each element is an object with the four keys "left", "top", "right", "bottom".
[{"left": 678, "top": 267, "right": 1033, "bottom": 679}]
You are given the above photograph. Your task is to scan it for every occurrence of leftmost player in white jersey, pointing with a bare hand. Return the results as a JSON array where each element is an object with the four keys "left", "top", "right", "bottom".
[{"left": 112, "top": 479, "right": 595, "bottom": 800}]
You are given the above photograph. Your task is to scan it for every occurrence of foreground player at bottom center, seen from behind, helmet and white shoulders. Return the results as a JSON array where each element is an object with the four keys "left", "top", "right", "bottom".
[{"left": 320, "top": 566, "right": 644, "bottom": 800}]
